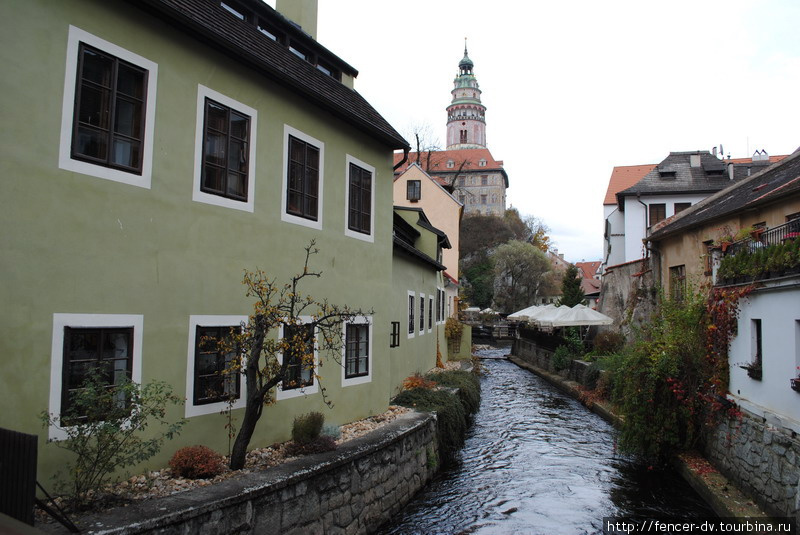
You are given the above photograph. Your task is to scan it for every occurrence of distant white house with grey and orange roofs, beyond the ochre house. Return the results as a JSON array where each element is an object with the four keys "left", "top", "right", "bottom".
[{"left": 603, "top": 151, "right": 785, "bottom": 270}]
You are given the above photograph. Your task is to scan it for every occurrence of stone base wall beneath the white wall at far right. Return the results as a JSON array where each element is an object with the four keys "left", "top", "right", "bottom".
[{"left": 704, "top": 412, "right": 800, "bottom": 526}]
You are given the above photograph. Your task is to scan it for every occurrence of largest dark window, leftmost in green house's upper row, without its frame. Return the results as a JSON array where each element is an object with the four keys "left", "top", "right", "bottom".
[{"left": 72, "top": 43, "right": 147, "bottom": 174}]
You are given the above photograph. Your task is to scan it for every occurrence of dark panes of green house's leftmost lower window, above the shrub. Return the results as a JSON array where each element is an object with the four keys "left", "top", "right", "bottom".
[{"left": 61, "top": 327, "right": 133, "bottom": 416}]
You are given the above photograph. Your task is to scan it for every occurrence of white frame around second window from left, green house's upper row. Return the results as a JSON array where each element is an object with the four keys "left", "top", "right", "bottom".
[{"left": 192, "top": 84, "right": 258, "bottom": 212}]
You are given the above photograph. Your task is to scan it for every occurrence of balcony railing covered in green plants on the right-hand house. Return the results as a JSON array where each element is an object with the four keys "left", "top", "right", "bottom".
[{"left": 716, "top": 219, "right": 800, "bottom": 285}]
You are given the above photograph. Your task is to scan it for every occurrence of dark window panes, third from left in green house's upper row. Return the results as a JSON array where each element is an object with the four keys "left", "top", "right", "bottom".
[{"left": 286, "top": 136, "right": 319, "bottom": 221}]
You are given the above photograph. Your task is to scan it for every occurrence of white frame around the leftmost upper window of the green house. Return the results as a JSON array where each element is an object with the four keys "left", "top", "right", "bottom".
[{"left": 58, "top": 25, "right": 158, "bottom": 189}]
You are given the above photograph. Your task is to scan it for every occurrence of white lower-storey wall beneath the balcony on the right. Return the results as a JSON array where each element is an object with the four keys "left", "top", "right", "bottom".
[{"left": 728, "top": 287, "right": 800, "bottom": 432}]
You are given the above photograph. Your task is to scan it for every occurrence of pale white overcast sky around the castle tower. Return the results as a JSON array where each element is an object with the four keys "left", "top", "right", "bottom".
[{"left": 290, "top": 0, "right": 800, "bottom": 262}]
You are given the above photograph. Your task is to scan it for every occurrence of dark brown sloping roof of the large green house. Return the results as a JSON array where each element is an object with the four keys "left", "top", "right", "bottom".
[{"left": 133, "top": 0, "right": 409, "bottom": 149}]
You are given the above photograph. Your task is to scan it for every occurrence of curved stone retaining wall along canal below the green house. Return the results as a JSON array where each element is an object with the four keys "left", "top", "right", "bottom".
[{"left": 37, "top": 413, "right": 438, "bottom": 535}]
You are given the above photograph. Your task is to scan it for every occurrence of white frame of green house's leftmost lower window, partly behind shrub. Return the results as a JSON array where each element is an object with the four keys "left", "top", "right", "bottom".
[{"left": 48, "top": 313, "right": 144, "bottom": 440}]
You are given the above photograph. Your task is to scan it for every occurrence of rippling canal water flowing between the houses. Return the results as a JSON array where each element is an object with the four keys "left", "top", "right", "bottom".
[{"left": 379, "top": 348, "right": 715, "bottom": 535}]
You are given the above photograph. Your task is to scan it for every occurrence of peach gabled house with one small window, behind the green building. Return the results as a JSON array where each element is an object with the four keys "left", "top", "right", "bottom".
[{"left": 394, "top": 163, "right": 464, "bottom": 317}]
